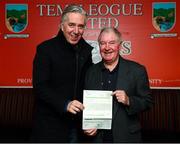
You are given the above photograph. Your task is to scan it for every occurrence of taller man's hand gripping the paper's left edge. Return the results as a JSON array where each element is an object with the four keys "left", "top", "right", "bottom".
[{"left": 67, "top": 100, "right": 84, "bottom": 114}]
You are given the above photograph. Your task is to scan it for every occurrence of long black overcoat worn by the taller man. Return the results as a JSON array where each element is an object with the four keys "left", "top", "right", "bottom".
[{"left": 31, "top": 31, "right": 92, "bottom": 142}]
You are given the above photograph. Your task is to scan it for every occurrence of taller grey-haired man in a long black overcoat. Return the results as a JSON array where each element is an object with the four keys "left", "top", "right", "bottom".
[{"left": 31, "top": 5, "right": 92, "bottom": 142}]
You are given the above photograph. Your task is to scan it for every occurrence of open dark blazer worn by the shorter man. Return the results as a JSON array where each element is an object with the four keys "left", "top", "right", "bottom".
[{"left": 85, "top": 57, "right": 152, "bottom": 142}]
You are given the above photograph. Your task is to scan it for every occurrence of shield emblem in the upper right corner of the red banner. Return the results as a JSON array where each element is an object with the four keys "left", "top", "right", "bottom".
[{"left": 152, "top": 2, "right": 176, "bottom": 32}]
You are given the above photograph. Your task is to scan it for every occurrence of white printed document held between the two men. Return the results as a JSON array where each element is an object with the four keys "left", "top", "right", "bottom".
[{"left": 82, "top": 90, "right": 113, "bottom": 129}]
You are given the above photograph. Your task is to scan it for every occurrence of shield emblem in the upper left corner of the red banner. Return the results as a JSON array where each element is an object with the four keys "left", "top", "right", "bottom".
[{"left": 5, "top": 4, "right": 28, "bottom": 33}]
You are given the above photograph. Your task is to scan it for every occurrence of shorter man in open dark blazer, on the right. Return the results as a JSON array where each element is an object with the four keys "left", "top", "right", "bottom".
[{"left": 84, "top": 28, "right": 152, "bottom": 143}]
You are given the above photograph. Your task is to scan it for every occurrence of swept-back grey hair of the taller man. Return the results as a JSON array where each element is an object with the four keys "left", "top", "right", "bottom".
[{"left": 61, "top": 4, "right": 87, "bottom": 23}]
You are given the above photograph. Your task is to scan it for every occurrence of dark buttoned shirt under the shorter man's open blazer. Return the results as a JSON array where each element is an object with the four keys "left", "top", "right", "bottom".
[{"left": 102, "top": 62, "right": 118, "bottom": 143}]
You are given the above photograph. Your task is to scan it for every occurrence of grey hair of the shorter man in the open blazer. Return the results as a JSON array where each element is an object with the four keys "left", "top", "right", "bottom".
[{"left": 98, "top": 27, "right": 122, "bottom": 44}]
